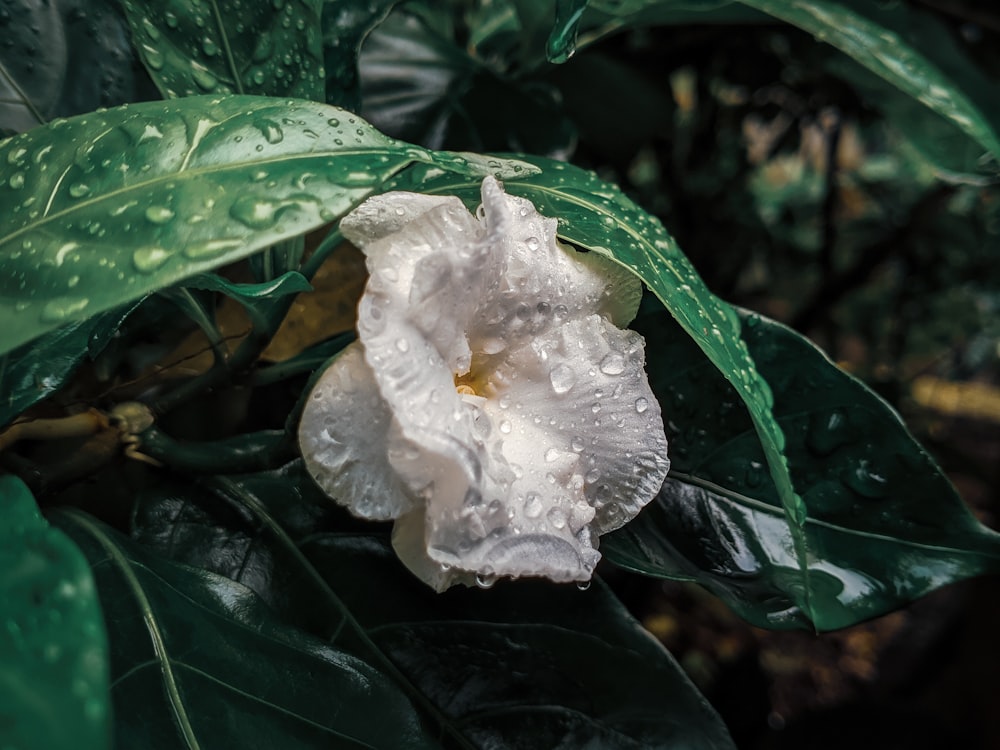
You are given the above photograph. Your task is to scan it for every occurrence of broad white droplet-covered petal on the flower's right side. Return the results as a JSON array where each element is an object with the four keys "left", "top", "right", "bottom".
[{"left": 484, "top": 315, "right": 670, "bottom": 534}]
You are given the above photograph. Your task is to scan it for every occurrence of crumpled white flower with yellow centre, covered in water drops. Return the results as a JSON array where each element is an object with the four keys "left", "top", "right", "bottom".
[{"left": 299, "top": 177, "right": 669, "bottom": 591}]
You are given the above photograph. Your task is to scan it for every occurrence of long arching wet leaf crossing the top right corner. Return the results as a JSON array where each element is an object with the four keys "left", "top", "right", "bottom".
[{"left": 740, "top": 0, "right": 1000, "bottom": 166}]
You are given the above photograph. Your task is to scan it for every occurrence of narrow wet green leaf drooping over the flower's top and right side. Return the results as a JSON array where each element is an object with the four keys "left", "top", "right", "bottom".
[{"left": 382, "top": 157, "right": 810, "bottom": 611}]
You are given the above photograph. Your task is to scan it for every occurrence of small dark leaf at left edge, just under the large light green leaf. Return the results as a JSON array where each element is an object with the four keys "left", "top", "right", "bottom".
[{"left": 0, "top": 303, "right": 137, "bottom": 427}]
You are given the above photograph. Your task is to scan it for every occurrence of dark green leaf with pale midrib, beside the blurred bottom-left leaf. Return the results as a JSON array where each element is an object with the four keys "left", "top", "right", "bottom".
[{"left": 51, "top": 511, "right": 439, "bottom": 750}]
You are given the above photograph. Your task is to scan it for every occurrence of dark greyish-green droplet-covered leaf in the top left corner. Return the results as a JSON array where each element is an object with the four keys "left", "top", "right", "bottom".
[{"left": 0, "top": 0, "right": 141, "bottom": 135}]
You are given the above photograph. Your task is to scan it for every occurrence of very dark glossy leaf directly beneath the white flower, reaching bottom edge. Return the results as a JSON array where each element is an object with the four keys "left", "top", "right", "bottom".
[{"left": 125, "top": 463, "right": 732, "bottom": 750}]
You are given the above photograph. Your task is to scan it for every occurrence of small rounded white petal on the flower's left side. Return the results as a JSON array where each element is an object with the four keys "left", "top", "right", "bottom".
[{"left": 299, "top": 342, "right": 414, "bottom": 520}]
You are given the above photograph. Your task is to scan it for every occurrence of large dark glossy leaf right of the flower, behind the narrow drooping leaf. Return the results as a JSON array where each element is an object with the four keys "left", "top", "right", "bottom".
[{"left": 601, "top": 312, "right": 1000, "bottom": 630}]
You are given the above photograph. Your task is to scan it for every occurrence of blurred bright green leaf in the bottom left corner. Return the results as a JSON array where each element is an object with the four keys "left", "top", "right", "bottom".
[{"left": 0, "top": 476, "right": 111, "bottom": 750}]
